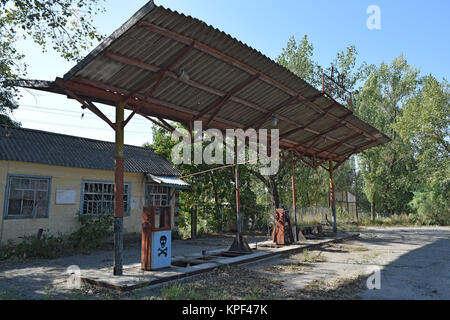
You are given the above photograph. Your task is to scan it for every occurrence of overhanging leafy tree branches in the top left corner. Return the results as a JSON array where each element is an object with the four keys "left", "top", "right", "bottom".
[{"left": 0, "top": 0, "right": 103, "bottom": 125}]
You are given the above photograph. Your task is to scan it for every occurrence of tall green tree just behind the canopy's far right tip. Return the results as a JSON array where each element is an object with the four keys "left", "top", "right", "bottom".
[{"left": 355, "top": 55, "right": 420, "bottom": 218}]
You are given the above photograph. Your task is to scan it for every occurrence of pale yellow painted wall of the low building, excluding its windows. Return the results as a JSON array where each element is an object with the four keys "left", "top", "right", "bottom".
[{"left": 0, "top": 161, "right": 174, "bottom": 243}]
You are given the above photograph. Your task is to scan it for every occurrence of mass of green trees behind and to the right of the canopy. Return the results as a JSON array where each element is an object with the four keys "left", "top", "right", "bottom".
[{"left": 149, "top": 36, "right": 450, "bottom": 230}]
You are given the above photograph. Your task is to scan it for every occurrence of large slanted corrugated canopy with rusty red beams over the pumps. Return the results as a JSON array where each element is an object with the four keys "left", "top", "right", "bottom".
[{"left": 16, "top": 1, "right": 389, "bottom": 167}]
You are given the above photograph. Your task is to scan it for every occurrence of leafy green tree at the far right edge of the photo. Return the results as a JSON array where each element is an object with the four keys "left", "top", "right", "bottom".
[{"left": 394, "top": 75, "right": 450, "bottom": 224}]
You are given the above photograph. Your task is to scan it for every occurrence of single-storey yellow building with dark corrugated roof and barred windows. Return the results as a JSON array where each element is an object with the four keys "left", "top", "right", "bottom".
[{"left": 0, "top": 125, "right": 187, "bottom": 243}]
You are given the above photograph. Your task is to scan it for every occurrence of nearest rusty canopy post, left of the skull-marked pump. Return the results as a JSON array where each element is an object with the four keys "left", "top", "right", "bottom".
[{"left": 114, "top": 102, "right": 125, "bottom": 276}]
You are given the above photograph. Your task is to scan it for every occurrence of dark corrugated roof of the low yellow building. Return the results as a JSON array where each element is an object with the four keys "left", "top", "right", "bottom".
[{"left": 0, "top": 125, "right": 181, "bottom": 176}]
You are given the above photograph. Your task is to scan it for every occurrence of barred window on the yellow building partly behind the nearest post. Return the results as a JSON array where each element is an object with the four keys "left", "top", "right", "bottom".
[{"left": 81, "top": 181, "right": 130, "bottom": 215}]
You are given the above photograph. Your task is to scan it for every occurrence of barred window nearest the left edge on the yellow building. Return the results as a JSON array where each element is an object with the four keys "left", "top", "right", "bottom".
[{"left": 6, "top": 176, "right": 50, "bottom": 218}]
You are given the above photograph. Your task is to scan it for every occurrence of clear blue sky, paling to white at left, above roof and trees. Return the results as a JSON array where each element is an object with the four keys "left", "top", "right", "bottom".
[{"left": 13, "top": 0, "right": 450, "bottom": 145}]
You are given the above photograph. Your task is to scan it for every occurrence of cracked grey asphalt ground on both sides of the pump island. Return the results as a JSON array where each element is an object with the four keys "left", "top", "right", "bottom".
[{"left": 0, "top": 227, "right": 450, "bottom": 300}]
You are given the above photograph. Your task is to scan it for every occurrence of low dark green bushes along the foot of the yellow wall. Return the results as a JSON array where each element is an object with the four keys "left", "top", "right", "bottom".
[{"left": 0, "top": 215, "right": 113, "bottom": 260}]
